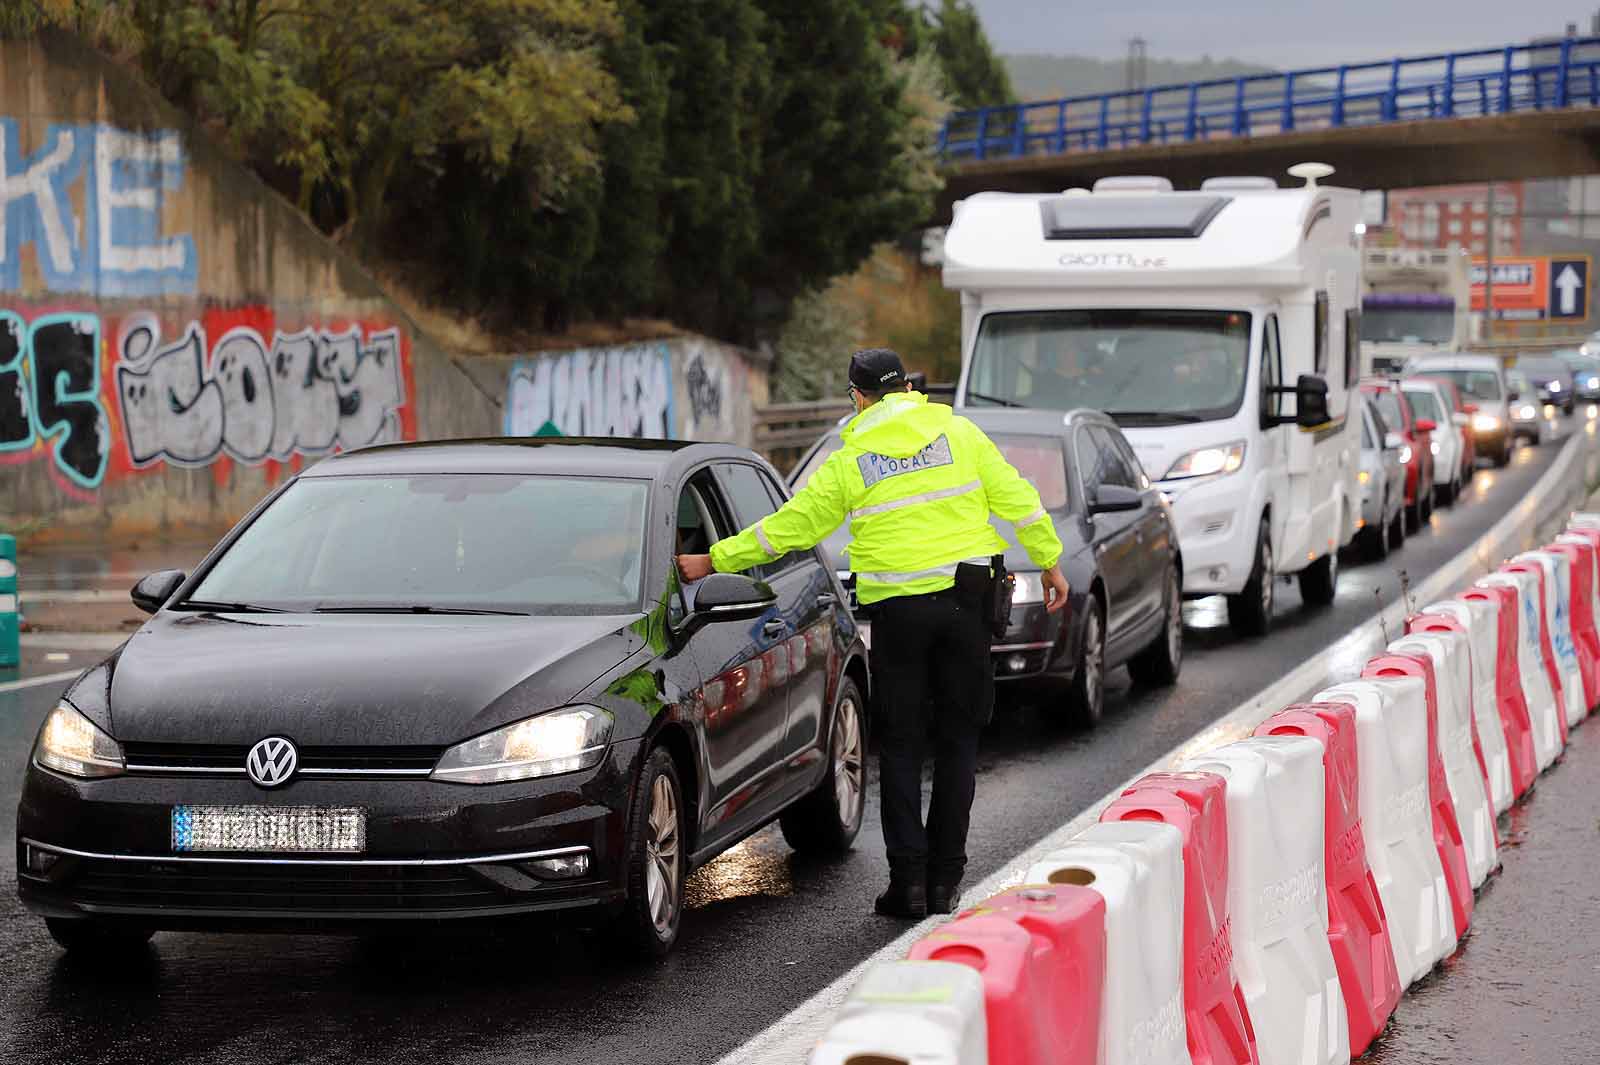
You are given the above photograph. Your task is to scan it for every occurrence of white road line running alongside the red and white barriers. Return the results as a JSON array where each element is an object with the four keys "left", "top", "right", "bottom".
[{"left": 729, "top": 433, "right": 1582, "bottom": 1065}]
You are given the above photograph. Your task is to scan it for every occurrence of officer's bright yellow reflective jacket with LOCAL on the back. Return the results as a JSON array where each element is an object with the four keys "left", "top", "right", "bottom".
[{"left": 710, "top": 392, "right": 1061, "bottom": 604}]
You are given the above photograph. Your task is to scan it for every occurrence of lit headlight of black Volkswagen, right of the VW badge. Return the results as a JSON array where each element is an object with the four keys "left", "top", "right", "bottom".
[{"left": 434, "top": 707, "right": 613, "bottom": 784}]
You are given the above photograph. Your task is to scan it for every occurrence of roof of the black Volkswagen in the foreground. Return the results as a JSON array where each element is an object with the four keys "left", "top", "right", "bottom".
[{"left": 302, "top": 437, "right": 736, "bottom": 478}]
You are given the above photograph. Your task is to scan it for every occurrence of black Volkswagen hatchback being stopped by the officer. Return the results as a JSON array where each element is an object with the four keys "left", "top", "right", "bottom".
[{"left": 18, "top": 440, "right": 867, "bottom": 955}]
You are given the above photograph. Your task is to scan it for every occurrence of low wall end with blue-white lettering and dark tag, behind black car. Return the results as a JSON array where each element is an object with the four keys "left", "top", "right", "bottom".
[{"left": 506, "top": 337, "right": 752, "bottom": 441}]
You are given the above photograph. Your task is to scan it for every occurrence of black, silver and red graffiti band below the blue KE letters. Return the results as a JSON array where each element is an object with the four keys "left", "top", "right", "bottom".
[{"left": 0, "top": 307, "right": 416, "bottom": 493}]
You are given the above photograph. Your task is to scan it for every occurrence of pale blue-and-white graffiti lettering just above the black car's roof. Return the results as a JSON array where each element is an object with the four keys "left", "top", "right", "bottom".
[{"left": 506, "top": 344, "right": 675, "bottom": 440}]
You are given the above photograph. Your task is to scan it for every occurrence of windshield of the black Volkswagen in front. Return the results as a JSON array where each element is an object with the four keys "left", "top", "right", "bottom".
[{"left": 179, "top": 473, "right": 650, "bottom": 614}]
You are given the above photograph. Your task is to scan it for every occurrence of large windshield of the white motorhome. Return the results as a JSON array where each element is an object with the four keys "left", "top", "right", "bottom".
[{"left": 963, "top": 307, "right": 1250, "bottom": 425}]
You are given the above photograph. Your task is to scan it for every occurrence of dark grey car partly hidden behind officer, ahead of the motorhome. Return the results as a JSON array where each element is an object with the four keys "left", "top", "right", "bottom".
[{"left": 790, "top": 408, "right": 1184, "bottom": 724}]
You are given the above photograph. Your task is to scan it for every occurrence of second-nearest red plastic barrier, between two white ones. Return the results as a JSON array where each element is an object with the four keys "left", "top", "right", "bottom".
[{"left": 1101, "top": 772, "right": 1261, "bottom": 1065}]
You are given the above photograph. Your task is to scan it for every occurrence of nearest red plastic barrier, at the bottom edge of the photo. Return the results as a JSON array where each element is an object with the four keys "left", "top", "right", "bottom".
[{"left": 910, "top": 884, "right": 1106, "bottom": 1065}]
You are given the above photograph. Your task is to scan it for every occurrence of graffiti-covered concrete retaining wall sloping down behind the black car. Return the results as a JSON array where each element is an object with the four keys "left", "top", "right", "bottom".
[{"left": 0, "top": 34, "right": 766, "bottom": 542}]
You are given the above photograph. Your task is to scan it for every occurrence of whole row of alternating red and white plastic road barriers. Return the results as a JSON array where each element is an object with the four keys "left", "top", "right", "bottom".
[{"left": 810, "top": 513, "right": 1600, "bottom": 1065}]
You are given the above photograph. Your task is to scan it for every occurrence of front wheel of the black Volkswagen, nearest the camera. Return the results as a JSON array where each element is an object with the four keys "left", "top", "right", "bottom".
[{"left": 614, "top": 747, "right": 688, "bottom": 958}]
